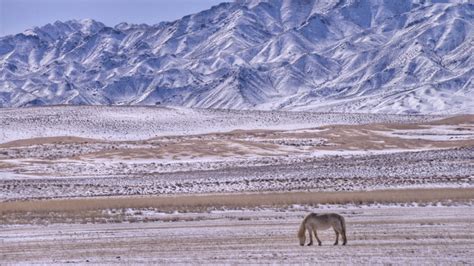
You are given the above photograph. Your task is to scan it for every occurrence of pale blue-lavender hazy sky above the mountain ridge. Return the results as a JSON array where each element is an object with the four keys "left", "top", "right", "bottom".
[{"left": 0, "top": 0, "right": 226, "bottom": 36}]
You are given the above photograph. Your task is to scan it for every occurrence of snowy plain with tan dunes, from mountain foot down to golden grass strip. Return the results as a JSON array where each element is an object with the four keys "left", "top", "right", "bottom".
[{"left": 0, "top": 106, "right": 474, "bottom": 200}]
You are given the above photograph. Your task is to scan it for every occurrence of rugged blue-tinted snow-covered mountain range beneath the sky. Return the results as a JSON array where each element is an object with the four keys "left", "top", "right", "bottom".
[{"left": 0, "top": 0, "right": 474, "bottom": 113}]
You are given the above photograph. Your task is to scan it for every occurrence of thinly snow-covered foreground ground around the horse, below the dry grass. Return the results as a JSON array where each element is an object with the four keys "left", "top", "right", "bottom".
[{"left": 0, "top": 203, "right": 474, "bottom": 265}]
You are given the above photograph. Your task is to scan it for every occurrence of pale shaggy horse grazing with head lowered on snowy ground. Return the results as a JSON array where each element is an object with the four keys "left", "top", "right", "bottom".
[{"left": 298, "top": 213, "right": 347, "bottom": 246}]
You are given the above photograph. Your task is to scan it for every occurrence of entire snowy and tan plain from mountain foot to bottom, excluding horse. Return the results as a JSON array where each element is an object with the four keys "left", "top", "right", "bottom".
[{"left": 0, "top": 106, "right": 474, "bottom": 264}]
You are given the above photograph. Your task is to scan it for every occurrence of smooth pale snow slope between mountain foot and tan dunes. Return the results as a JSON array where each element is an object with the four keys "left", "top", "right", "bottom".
[{"left": 0, "top": 106, "right": 443, "bottom": 143}]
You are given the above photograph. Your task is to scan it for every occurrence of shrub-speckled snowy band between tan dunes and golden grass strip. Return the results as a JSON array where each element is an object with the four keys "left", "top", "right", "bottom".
[{"left": 0, "top": 148, "right": 474, "bottom": 200}]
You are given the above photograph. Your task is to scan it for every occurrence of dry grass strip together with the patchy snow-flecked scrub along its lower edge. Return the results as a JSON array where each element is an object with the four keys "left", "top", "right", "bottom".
[{"left": 0, "top": 188, "right": 474, "bottom": 225}]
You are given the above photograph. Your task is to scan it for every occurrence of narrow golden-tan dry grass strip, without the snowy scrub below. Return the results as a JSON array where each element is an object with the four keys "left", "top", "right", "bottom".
[{"left": 0, "top": 188, "right": 474, "bottom": 214}]
